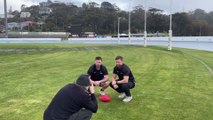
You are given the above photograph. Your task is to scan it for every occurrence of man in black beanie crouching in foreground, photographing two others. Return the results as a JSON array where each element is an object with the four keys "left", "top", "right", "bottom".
[{"left": 44, "top": 75, "right": 98, "bottom": 120}]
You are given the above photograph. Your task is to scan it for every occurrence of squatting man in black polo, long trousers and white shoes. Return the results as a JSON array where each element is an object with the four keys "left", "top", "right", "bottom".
[{"left": 110, "top": 56, "right": 135, "bottom": 102}]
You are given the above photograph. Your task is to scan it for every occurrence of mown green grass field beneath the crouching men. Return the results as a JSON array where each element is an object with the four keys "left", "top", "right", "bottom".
[{"left": 0, "top": 44, "right": 213, "bottom": 120}]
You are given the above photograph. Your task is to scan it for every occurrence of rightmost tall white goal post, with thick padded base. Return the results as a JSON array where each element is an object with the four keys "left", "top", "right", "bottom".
[{"left": 168, "top": 0, "right": 172, "bottom": 50}]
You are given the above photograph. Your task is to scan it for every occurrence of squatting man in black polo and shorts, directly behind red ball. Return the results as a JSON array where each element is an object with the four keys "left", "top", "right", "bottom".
[{"left": 87, "top": 57, "right": 109, "bottom": 95}]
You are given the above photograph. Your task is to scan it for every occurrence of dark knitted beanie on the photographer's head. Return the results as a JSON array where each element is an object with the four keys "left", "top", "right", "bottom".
[{"left": 76, "top": 74, "right": 90, "bottom": 86}]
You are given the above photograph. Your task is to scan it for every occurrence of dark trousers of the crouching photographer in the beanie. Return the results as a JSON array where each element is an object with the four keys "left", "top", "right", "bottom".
[{"left": 68, "top": 109, "right": 92, "bottom": 120}]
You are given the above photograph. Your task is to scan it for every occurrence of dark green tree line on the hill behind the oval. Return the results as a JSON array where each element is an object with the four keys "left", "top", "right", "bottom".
[{"left": 0, "top": 2, "right": 213, "bottom": 36}]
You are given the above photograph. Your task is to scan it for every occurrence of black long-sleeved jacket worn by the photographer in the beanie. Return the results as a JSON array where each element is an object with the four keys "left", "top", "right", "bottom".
[{"left": 44, "top": 84, "right": 98, "bottom": 120}]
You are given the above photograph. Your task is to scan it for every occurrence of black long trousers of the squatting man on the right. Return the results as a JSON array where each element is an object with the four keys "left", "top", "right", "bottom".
[{"left": 110, "top": 82, "right": 135, "bottom": 96}]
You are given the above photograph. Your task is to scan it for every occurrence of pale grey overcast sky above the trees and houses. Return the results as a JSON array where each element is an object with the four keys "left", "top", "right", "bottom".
[{"left": 0, "top": 0, "right": 213, "bottom": 14}]
